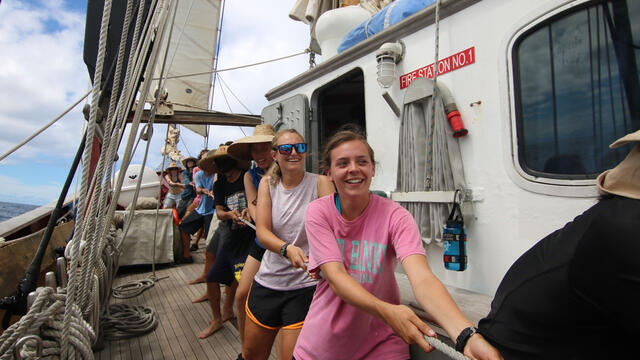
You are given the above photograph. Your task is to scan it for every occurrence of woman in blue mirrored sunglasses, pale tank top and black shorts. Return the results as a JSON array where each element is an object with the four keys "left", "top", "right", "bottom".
[{"left": 242, "top": 129, "right": 334, "bottom": 359}]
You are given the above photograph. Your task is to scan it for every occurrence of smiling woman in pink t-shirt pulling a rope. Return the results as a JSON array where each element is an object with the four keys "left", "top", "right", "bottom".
[{"left": 294, "top": 131, "right": 502, "bottom": 360}]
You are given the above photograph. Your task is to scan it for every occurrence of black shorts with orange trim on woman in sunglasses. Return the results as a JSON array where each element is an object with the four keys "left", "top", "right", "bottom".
[{"left": 245, "top": 281, "right": 316, "bottom": 330}]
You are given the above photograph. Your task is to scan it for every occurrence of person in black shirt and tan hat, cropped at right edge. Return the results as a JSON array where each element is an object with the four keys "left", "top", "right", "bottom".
[{"left": 479, "top": 130, "right": 640, "bottom": 359}]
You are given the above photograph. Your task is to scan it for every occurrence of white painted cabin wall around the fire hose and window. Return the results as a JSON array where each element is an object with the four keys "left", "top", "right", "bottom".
[{"left": 270, "top": 0, "right": 596, "bottom": 295}]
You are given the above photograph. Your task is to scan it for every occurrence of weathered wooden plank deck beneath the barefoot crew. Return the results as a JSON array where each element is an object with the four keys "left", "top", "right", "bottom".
[{"left": 95, "top": 248, "right": 276, "bottom": 360}]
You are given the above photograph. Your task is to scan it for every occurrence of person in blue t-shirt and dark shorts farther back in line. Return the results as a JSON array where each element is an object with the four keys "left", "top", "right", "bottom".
[{"left": 178, "top": 150, "right": 216, "bottom": 263}]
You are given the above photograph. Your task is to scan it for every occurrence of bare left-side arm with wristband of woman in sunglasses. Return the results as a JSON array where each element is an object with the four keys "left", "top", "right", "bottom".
[{"left": 256, "top": 176, "right": 309, "bottom": 271}]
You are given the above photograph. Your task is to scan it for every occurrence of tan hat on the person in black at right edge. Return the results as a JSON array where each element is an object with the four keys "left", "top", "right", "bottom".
[{"left": 597, "top": 130, "right": 640, "bottom": 199}]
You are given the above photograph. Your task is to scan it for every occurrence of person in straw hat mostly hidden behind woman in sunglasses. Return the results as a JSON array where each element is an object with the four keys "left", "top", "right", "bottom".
[{"left": 228, "top": 124, "right": 276, "bottom": 352}]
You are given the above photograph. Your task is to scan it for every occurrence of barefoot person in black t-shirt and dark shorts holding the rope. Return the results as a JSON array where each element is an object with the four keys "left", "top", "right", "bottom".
[{"left": 198, "top": 146, "right": 255, "bottom": 339}]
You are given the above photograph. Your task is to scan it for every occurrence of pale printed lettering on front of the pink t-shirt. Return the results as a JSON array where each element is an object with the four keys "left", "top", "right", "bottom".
[{"left": 336, "top": 239, "right": 387, "bottom": 284}]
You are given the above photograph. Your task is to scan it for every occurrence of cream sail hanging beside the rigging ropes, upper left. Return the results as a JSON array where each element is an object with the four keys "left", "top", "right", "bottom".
[{"left": 147, "top": 0, "right": 221, "bottom": 136}]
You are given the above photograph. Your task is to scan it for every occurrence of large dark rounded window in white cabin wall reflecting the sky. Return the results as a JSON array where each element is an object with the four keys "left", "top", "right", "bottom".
[{"left": 512, "top": 0, "right": 640, "bottom": 179}]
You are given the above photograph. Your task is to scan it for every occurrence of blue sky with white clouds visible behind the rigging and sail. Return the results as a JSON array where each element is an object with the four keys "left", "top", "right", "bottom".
[{"left": 0, "top": 0, "right": 309, "bottom": 205}]
